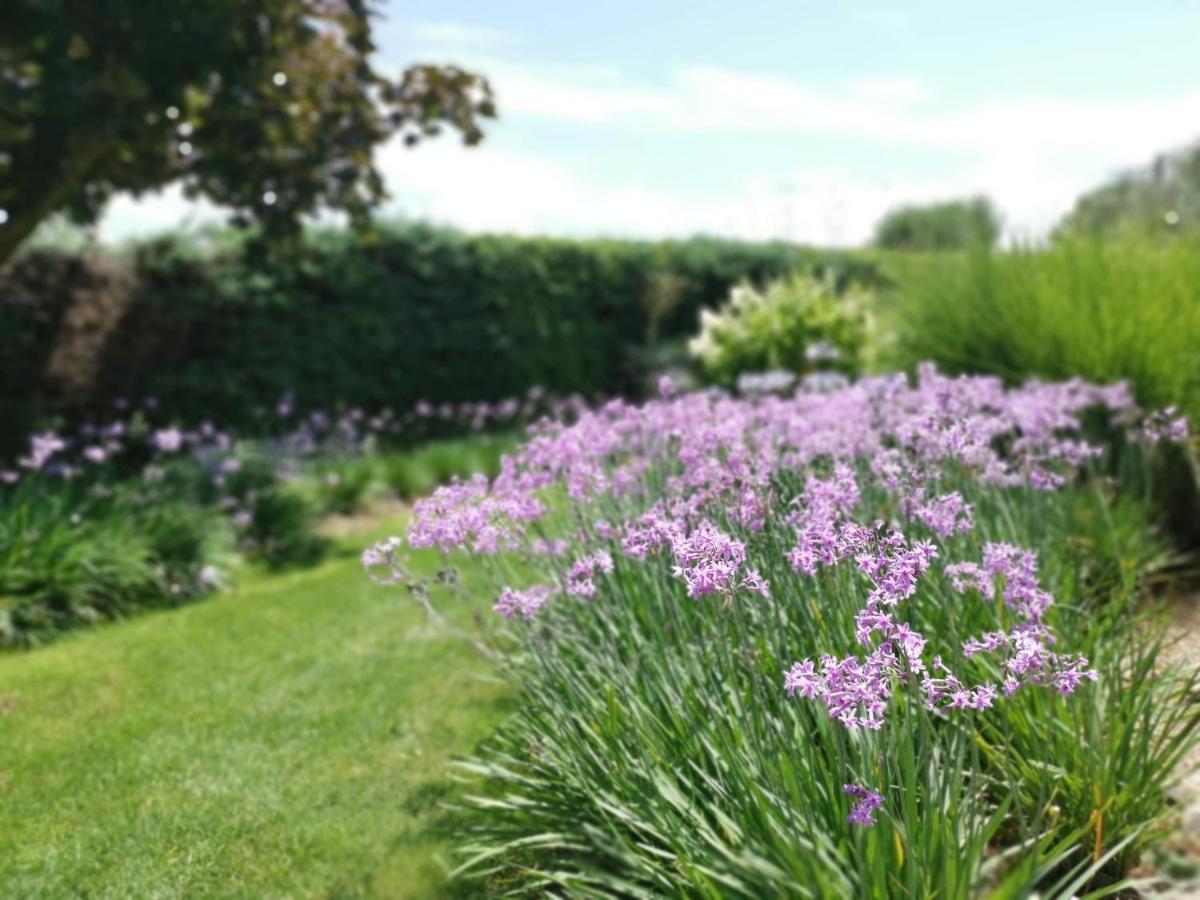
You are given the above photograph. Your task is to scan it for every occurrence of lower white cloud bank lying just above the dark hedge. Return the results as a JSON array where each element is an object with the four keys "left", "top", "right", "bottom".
[{"left": 380, "top": 143, "right": 971, "bottom": 246}]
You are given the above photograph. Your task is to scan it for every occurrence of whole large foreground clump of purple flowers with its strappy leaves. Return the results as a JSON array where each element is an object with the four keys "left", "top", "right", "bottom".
[{"left": 364, "top": 367, "right": 1200, "bottom": 898}]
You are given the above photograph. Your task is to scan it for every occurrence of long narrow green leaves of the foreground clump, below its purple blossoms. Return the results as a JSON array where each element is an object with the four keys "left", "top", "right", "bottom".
[{"left": 463, "top": 465, "right": 1200, "bottom": 898}]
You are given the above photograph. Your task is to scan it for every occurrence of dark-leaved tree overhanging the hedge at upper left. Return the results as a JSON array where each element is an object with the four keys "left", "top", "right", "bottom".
[{"left": 0, "top": 0, "right": 496, "bottom": 263}]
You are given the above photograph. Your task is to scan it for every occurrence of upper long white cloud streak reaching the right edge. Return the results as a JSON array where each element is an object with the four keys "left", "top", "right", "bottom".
[{"left": 488, "top": 64, "right": 1200, "bottom": 157}]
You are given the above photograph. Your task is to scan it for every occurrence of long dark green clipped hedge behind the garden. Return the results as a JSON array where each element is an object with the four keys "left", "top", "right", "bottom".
[{"left": 0, "top": 220, "right": 876, "bottom": 441}]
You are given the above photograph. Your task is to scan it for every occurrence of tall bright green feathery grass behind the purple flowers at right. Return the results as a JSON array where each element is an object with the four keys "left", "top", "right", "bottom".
[{"left": 892, "top": 234, "right": 1200, "bottom": 427}]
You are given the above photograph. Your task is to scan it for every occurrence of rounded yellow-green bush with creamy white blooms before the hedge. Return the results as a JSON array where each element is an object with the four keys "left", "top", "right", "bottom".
[{"left": 689, "top": 275, "right": 868, "bottom": 386}]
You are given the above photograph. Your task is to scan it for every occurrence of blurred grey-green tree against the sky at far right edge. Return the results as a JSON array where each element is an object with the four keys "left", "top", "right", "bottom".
[{"left": 1058, "top": 145, "right": 1200, "bottom": 239}]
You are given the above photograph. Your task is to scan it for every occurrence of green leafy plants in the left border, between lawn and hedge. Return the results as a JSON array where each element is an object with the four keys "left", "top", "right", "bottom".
[{"left": 0, "top": 427, "right": 525, "bottom": 647}]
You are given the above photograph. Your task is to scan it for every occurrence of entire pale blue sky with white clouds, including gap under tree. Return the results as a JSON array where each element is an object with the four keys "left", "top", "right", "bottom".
[{"left": 101, "top": 0, "right": 1200, "bottom": 245}]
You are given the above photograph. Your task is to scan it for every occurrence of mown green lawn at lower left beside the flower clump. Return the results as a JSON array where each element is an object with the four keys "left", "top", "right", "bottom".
[{"left": 0, "top": 520, "right": 509, "bottom": 898}]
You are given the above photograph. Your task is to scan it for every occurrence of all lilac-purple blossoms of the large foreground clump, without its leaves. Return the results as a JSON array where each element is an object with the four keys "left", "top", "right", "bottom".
[{"left": 376, "top": 366, "right": 1186, "bottom": 826}]
